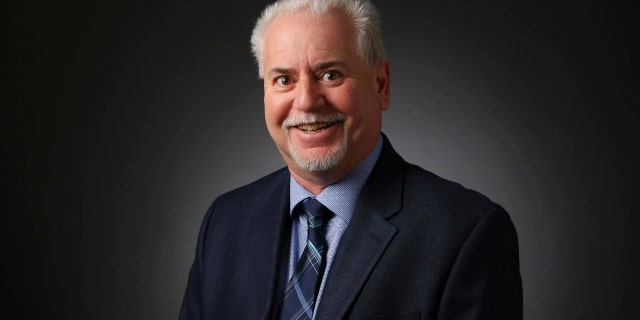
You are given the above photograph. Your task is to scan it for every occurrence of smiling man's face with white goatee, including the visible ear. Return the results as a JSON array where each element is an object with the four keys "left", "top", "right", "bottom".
[{"left": 263, "top": 11, "right": 389, "bottom": 183}]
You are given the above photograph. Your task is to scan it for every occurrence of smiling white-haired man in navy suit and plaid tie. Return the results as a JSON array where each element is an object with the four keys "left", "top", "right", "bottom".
[{"left": 180, "top": 0, "right": 522, "bottom": 320}]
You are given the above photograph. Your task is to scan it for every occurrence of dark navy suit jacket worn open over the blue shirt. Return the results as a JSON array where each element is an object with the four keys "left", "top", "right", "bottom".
[{"left": 180, "top": 137, "right": 522, "bottom": 320}]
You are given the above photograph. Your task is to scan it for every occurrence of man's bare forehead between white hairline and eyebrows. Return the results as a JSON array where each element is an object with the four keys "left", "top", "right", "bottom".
[{"left": 264, "top": 11, "right": 355, "bottom": 67}]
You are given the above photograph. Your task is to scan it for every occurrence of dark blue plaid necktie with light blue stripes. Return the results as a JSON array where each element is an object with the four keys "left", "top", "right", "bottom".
[{"left": 280, "top": 198, "right": 331, "bottom": 320}]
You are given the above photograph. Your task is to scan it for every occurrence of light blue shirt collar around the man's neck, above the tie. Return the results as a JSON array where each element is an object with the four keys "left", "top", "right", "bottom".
[{"left": 289, "top": 136, "right": 382, "bottom": 223}]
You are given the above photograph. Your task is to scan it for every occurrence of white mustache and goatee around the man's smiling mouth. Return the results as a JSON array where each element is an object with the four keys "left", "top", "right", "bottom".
[{"left": 282, "top": 113, "right": 347, "bottom": 172}]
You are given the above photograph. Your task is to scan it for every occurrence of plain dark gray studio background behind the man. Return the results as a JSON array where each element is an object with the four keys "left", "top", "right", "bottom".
[{"left": 0, "top": 0, "right": 640, "bottom": 319}]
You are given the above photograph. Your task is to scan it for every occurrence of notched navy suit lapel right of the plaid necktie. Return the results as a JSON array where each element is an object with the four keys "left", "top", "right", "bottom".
[{"left": 316, "top": 137, "right": 404, "bottom": 320}]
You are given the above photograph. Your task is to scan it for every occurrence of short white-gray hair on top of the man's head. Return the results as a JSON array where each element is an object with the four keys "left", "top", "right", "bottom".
[{"left": 251, "top": 0, "right": 386, "bottom": 78}]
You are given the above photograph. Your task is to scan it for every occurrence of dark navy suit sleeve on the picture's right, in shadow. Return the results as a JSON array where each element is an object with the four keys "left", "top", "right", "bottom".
[{"left": 438, "top": 208, "right": 522, "bottom": 320}]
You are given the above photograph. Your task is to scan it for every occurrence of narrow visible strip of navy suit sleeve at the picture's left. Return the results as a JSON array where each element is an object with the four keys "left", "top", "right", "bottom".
[{"left": 179, "top": 202, "right": 215, "bottom": 320}]
